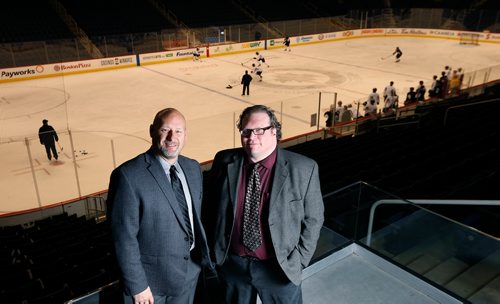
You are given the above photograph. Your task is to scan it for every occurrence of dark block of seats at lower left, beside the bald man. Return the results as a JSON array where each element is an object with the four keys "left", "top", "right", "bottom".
[{"left": 0, "top": 213, "right": 119, "bottom": 304}]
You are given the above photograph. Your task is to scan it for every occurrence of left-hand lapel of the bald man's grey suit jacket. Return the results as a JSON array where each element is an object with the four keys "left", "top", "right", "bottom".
[{"left": 146, "top": 150, "right": 187, "bottom": 231}]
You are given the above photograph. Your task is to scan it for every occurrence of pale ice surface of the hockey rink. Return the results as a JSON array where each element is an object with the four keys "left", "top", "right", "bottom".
[{"left": 0, "top": 37, "right": 500, "bottom": 212}]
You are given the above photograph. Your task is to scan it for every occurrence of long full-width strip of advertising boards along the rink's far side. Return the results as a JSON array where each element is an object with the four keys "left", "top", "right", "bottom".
[{"left": 0, "top": 28, "right": 500, "bottom": 83}]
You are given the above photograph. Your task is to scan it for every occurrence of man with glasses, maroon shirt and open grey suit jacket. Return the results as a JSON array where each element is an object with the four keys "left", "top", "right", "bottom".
[{"left": 204, "top": 105, "right": 324, "bottom": 304}]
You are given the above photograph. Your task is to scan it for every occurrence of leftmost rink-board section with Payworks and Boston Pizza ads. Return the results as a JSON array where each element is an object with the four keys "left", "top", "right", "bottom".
[{"left": 0, "top": 55, "right": 137, "bottom": 83}]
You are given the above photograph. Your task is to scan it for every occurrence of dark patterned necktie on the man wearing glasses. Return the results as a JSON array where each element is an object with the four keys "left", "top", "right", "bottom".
[{"left": 243, "top": 164, "right": 262, "bottom": 251}]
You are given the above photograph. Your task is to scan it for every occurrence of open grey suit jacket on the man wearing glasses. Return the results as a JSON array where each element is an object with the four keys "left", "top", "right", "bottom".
[{"left": 204, "top": 148, "right": 324, "bottom": 285}]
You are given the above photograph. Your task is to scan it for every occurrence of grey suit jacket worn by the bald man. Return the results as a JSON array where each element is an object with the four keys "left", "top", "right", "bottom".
[{"left": 108, "top": 149, "right": 210, "bottom": 296}]
